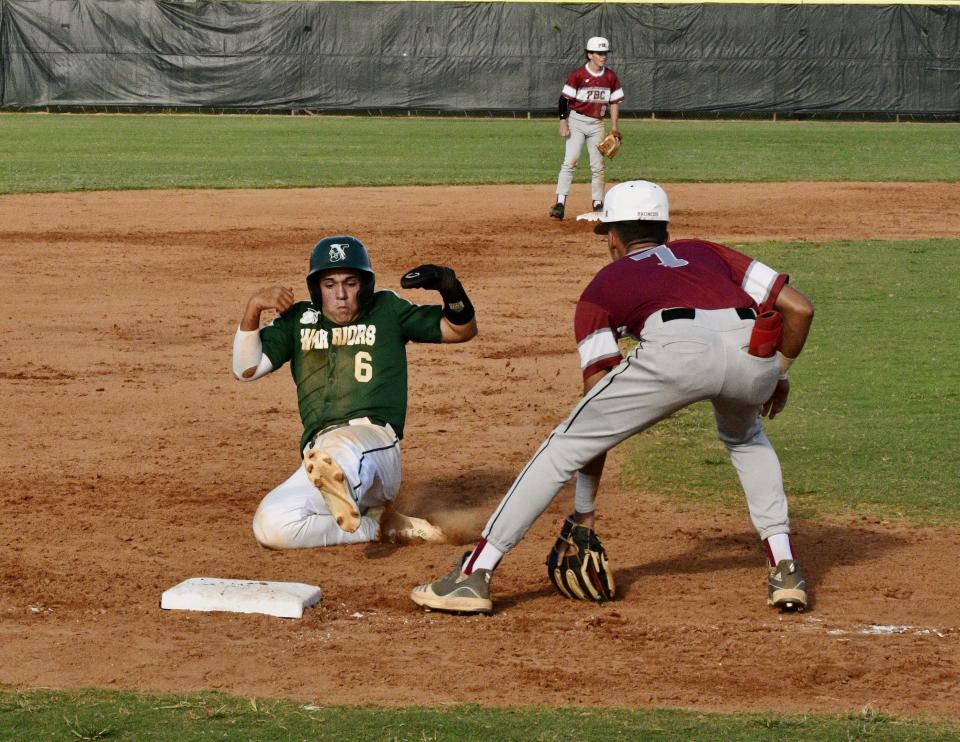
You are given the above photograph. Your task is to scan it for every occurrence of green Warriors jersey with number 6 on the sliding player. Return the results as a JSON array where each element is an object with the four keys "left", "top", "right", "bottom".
[{"left": 260, "top": 291, "right": 442, "bottom": 451}]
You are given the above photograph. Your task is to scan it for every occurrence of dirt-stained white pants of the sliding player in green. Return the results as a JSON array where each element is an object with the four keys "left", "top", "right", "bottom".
[{"left": 253, "top": 418, "right": 400, "bottom": 549}]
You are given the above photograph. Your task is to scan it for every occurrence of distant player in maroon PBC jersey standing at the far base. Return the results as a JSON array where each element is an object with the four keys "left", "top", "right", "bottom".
[{"left": 550, "top": 36, "right": 623, "bottom": 219}]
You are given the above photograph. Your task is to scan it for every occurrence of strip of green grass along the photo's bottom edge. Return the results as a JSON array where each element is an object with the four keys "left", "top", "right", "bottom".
[{"left": 0, "top": 690, "right": 960, "bottom": 742}]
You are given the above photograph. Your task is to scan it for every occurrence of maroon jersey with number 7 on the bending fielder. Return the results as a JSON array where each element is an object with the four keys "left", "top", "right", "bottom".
[{"left": 574, "top": 240, "right": 790, "bottom": 378}]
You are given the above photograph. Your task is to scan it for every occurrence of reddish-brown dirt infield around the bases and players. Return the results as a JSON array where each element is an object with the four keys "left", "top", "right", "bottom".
[{"left": 0, "top": 183, "right": 960, "bottom": 717}]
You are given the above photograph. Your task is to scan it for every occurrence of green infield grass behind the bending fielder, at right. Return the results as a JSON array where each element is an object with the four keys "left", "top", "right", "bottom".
[{"left": 623, "top": 240, "right": 960, "bottom": 522}]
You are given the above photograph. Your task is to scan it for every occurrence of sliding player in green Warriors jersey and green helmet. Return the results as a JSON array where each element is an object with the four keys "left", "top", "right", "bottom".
[{"left": 233, "top": 236, "right": 477, "bottom": 549}]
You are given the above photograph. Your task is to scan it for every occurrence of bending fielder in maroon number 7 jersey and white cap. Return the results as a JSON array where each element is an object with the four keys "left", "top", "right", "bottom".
[{"left": 411, "top": 180, "right": 813, "bottom": 612}]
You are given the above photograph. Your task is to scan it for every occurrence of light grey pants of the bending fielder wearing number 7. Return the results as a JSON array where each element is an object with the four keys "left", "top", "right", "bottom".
[{"left": 483, "top": 309, "right": 790, "bottom": 552}]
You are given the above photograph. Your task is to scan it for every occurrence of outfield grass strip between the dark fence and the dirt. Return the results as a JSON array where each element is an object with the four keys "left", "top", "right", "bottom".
[{"left": 0, "top": 113, "right": 960, "bottom": 193}]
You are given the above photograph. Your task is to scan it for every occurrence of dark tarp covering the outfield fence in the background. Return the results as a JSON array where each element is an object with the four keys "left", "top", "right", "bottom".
[{"left": 0, "top": 0, "right": 960, "bottom": 115}]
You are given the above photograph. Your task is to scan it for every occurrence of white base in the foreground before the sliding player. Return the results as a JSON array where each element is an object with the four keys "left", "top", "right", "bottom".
[{"left": 160, "top": 577, "right": 320, "bottom": 618}]
